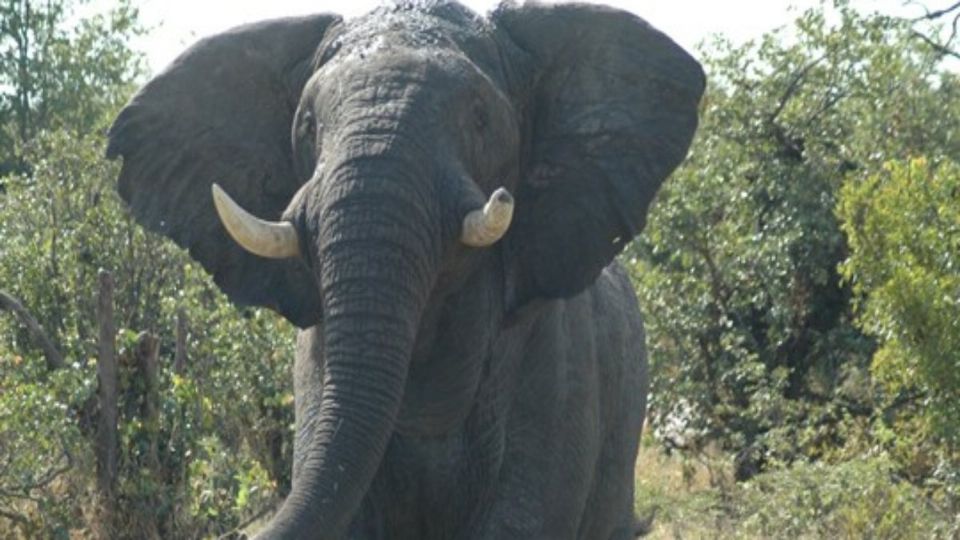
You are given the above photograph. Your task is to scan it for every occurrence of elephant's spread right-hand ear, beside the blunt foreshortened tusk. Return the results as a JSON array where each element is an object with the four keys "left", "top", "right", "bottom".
[{"left": 493, "top": 3, "right": 705, "bottom": 298}]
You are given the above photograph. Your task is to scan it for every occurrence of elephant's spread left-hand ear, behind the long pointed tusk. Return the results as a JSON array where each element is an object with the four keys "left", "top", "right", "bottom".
[{"left": 107, "top": 15, "right": 339, "bottom": 327}]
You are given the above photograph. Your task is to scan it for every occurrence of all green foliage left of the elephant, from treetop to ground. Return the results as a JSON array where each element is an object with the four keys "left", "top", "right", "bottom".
[{"left": 0, "top": 1, "right": 294, "bottom": 538}]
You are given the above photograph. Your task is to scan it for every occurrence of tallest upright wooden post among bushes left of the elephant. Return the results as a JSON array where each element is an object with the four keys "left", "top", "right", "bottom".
[{"left": 95, "top": 269, "right": 117, "bottom": 508}]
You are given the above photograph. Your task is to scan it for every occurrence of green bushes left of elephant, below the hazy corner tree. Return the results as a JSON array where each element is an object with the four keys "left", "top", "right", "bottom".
[{"left": 0, "top": 127, "right": 295, "bottom": 536}]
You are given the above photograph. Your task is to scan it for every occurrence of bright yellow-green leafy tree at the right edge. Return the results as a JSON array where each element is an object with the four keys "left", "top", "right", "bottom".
[{"left": 837, "top": 157, "right": 960, "bottom": 490}]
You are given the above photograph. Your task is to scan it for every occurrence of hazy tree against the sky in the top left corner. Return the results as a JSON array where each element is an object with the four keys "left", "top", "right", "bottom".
[{"left": 0, "top": 0, "right": 143, "bottom": 176}]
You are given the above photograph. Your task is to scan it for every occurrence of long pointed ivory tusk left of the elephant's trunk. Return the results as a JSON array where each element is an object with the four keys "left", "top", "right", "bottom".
[{"left": 212, "top": 184, "right": 300, "bottom": 259}]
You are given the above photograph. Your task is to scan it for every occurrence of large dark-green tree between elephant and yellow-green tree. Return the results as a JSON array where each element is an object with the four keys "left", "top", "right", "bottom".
[{"left": 627, "top": 2, "right": 960, "bottom": 470}]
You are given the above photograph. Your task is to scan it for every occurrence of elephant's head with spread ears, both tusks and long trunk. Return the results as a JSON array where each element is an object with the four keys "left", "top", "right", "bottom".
[{"left": 107, "top": 2, "right": 704, "bottom": 538}]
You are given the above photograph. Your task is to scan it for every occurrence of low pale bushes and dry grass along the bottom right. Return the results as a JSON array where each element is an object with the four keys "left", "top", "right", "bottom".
[{"left": 637, "top": 450, "right": 960, "bottom": 540}]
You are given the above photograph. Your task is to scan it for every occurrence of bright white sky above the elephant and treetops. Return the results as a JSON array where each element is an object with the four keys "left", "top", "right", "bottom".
[{"left": 95, "top": 0, "right": 924, "bottom": 71}]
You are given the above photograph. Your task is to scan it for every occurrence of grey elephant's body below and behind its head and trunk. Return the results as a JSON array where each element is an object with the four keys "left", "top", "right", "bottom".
[{"left": 294, "top": 263, "right": 648, "bottom": 540}]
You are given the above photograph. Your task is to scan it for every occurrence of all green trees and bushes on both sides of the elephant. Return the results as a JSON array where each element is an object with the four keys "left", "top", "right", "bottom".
[{"left": 0, "top": 0, "right": 960, "bottom": 538}]
